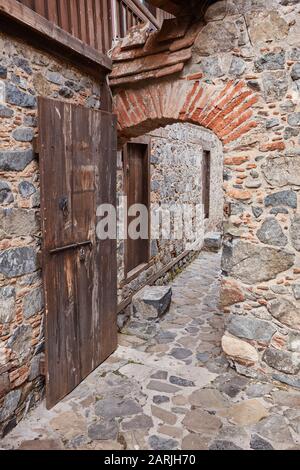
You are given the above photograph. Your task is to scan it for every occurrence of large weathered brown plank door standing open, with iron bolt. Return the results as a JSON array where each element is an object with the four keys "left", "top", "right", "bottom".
[{"left": 39, "top": 98, "right": 117, "bottom": 408}]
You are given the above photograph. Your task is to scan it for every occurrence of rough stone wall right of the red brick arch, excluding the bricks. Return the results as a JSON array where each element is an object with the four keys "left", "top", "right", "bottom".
[{"left": 196, "top": 0, "right": 300, "bottom": 387}]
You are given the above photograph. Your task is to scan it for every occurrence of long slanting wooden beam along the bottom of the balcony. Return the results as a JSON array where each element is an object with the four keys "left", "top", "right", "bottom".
[{"left": 0, "top": 0, "right": 112, "bottom": 73}]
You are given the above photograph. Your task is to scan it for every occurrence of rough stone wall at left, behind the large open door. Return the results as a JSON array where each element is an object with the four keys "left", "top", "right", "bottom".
[{"left": 0, "top": 34, "right": 100, "bottom": 435}]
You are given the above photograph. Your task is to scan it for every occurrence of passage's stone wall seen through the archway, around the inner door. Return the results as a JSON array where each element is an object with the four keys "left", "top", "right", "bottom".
[{"left": 118, "top": 124, "right": 223, "bottom": 314}]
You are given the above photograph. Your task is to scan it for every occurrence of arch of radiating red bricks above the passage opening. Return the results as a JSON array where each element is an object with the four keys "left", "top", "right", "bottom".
[{"left": 114, "top": 78, "right": 258, "bottom": 144}]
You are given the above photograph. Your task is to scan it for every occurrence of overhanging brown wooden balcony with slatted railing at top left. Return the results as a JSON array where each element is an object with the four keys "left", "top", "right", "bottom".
[{"left": 0, "top": 0, "right": 172, "bottom": 74}]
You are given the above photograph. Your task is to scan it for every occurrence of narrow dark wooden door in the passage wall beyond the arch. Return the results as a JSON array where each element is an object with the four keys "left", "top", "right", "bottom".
[{"left": 125, "top": 142, "right": 150, "bottom": 274}]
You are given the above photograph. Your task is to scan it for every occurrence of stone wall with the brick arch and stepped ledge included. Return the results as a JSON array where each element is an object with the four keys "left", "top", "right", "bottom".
[{"left": 111, "top": 0, "right": 300, "bottom": 388}]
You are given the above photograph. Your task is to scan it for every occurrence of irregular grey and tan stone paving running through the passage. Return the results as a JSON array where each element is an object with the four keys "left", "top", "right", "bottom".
[{"left": 0, "top": 252, "right": 300, "bottom": 450}]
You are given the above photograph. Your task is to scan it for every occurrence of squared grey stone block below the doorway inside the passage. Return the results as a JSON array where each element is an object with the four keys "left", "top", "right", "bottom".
[{"left": 132, "top": 286, "right": 172, "bottom": 321}]
